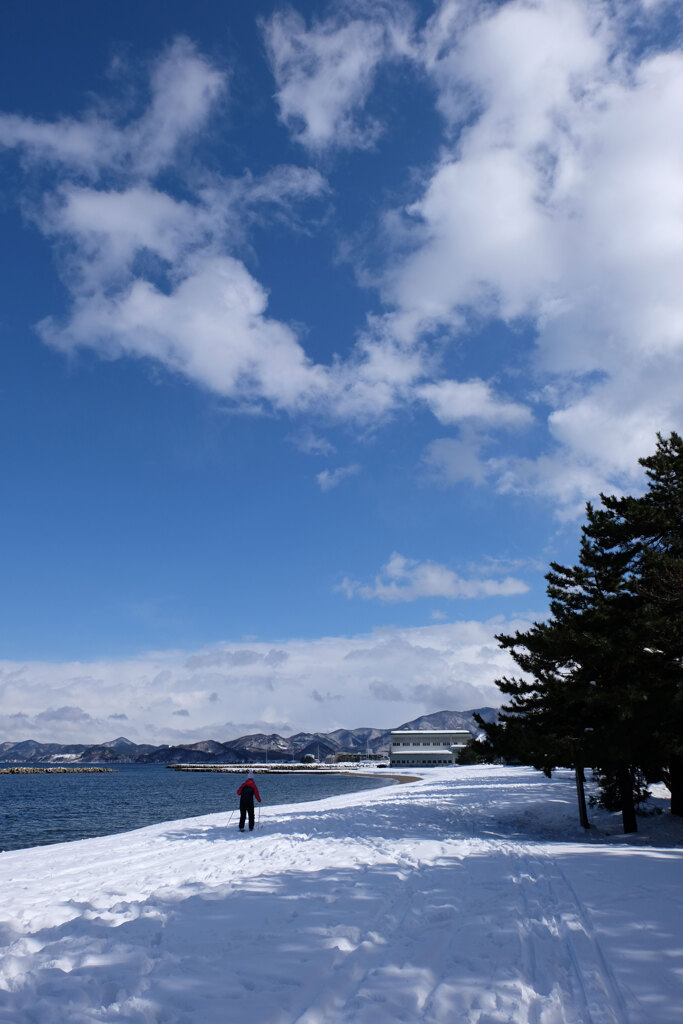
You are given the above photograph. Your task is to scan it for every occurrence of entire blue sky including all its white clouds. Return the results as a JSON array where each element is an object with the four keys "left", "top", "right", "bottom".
[{"left": 0, "top": 0, "right": 683, "bottom": 742}]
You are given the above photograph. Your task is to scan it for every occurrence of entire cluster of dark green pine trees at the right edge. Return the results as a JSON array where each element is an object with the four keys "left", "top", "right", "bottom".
[{"left": 478, "top": 433, "right": 683, "bottom": 830}]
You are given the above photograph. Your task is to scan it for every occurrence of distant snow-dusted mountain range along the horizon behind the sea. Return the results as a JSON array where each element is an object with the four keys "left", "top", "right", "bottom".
[{"left": 0, "top": 708, "right": 498, "bottom": 764}]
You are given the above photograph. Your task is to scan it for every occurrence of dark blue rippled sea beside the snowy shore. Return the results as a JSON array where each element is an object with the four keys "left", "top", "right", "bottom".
[{"left": 0, "top": 765, "right": 393, "bottom": 850}]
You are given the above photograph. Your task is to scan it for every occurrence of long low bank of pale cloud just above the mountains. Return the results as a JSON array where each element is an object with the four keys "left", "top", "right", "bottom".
[{"left": 0, "top": 618, "right": 529, "bottom": 743}]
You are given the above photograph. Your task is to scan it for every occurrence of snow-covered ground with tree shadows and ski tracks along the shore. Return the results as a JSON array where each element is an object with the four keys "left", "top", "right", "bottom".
[{"left": 0, "top": 766, "right": 683, "bottom": 1024}]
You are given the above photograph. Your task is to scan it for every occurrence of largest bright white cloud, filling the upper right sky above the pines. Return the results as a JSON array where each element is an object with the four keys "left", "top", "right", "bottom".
[{"left": 374, "top": 0, "right": 683, "bottom": 514}]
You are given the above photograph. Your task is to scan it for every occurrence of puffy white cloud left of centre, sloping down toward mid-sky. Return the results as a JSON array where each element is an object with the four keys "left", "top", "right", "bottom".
[{"left": 38, "top": 214, "right": 428, "bottom": 421}]
